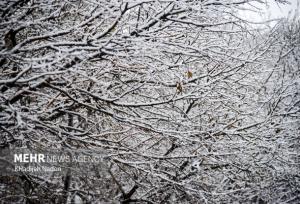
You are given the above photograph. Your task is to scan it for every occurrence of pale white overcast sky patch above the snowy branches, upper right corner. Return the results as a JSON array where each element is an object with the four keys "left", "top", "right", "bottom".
[{"left": 240, "top": 0, "right": 300, "bottom": 25}]
